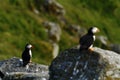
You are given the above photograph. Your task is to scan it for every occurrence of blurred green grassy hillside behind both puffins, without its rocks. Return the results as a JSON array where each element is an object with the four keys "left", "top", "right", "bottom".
[{"left": 0, "top": 0, "right": 120, "bottom": 64}]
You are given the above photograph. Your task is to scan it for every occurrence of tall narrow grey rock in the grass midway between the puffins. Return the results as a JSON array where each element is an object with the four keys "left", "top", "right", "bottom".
[{"left": 43, "top": 21, "right": 62, "bottom": 58}]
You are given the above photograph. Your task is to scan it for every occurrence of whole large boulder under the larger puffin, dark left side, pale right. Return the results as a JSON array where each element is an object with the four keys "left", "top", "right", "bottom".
[{"left": 49, "top": 47, "right": 120, "bottom": 80}]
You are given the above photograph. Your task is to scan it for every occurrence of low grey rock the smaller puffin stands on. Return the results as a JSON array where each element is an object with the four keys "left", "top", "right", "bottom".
[{"left": 0, "top": 57, "right": 49, "bottom": 80}]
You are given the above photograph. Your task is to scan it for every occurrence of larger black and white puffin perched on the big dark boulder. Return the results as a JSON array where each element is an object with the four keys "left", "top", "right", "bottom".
[{"left": 79, "top": 27, "right": 99, "bottom": 51}]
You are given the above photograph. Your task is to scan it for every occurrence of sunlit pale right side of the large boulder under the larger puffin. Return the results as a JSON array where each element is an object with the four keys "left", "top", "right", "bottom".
[{"left": 95, "top": 48, "right": 120, "bottom": 80}]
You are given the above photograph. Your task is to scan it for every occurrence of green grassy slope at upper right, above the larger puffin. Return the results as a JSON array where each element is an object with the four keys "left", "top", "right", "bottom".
[{"left": 59, "top": 0, "right": 120, "bottom": 43}]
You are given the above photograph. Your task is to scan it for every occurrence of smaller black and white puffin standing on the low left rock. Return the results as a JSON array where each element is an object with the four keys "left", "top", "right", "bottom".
[{"left": 22, "top": 44, "right": 32, "bottom": 66}]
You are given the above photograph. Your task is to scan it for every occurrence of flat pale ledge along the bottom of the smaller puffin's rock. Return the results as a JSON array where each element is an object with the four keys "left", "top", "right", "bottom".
[{"left": 3, "top": 72, "right": 48, "bottom": 80}]
